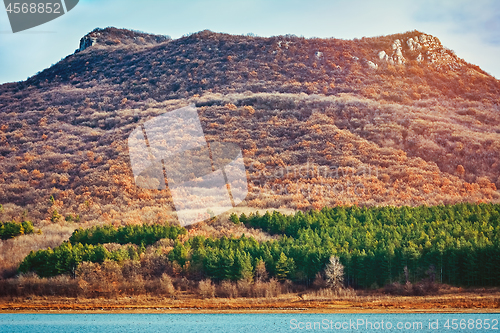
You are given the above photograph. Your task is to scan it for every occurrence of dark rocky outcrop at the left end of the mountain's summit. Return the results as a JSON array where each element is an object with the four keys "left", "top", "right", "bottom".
[{"left": 75, "top": 27, "right": 171, "bottom": 53}]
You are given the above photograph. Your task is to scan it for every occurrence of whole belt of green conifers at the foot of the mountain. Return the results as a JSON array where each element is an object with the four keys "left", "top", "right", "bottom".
[{"left": 20, "top": 204, "right": 500, "bottom": 288}]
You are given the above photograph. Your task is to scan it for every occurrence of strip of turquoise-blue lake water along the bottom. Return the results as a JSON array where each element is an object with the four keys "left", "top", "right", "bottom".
[{"left": 0, "top": 313, "right": 500, "bottom": 333}]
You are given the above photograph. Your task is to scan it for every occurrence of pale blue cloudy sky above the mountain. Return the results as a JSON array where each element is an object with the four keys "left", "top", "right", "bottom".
[{"left": 0, "top": 0, "right": 500, "bottom": 84}]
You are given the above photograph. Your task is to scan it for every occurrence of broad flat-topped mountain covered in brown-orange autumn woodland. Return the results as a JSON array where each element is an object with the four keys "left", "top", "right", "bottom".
[{"left": 0, "top": 28, "right": 500, "bottom": 224}]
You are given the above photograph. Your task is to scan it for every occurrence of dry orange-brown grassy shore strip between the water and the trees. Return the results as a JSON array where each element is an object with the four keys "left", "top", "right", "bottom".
[{"left": 0, "top": 292, "right": 500, "bottom": 314}]
